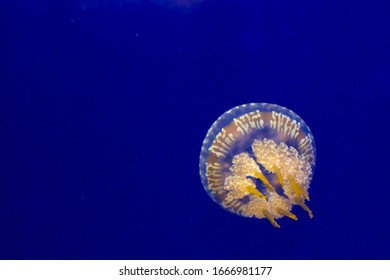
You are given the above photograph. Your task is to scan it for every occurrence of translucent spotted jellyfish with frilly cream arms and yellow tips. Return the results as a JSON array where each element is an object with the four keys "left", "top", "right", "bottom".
[{"left": 199, "top": 103, "right": 316, "bottom": 227}]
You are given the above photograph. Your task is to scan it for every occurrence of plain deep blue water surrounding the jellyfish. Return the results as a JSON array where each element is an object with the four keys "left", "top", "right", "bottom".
[{"left": 0, "top": 0, "right": 390, "bottom": 259}]
